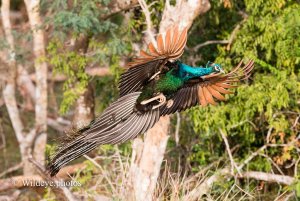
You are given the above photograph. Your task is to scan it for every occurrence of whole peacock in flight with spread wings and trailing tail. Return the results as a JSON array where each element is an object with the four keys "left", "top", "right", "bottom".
[{"left": 47, "top": 26, "right": 254, "bottom": 176}]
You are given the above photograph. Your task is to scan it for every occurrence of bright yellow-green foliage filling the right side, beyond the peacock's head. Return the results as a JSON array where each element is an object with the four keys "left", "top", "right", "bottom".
[{"left": 188, "top": 0, "right": 300, "bottom": 176}]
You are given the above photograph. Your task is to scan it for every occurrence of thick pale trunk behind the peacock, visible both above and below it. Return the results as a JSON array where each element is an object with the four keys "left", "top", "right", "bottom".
[{"left": 128, "top": 0, "right": 210, "bottom": 201}]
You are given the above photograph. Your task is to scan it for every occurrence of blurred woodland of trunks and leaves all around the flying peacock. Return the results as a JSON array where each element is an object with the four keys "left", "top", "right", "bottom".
[{"left": 0, "top": 0, "right": 300, "bottom": 201}]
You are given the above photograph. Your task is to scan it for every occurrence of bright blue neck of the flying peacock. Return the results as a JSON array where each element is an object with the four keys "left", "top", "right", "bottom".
[{"left": 178, "top": 62, "right": 213, "bottom": 81}]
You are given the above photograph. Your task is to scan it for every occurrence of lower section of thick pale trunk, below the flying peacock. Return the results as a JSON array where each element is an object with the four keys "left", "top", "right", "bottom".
[{"left": 127, "top": 116, "right": 170, "bottom": 200}]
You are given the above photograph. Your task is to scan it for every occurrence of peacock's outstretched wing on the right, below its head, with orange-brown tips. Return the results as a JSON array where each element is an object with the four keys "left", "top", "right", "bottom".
[{"left": 160, "top": 60, "right": 254, "bottom": 115}]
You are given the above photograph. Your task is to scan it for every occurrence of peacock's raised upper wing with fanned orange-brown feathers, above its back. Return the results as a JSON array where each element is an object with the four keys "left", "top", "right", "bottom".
[{"left": 119, "top": 26, "right": 187, "bottom": 96}]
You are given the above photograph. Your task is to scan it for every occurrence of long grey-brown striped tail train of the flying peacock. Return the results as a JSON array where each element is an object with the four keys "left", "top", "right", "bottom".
[{"left": 47, "top": 92, "right": 159, "bottom": 176}]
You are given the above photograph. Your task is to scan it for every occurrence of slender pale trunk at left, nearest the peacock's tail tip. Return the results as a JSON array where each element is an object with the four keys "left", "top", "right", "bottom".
[{"left": 25, "top": 0, "right": 48, "bottom": 169}]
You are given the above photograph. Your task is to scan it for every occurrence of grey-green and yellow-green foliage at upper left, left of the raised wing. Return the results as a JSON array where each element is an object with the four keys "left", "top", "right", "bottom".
[{"left": 45, "top": 0, "right": 131, "bottom": 114}]
